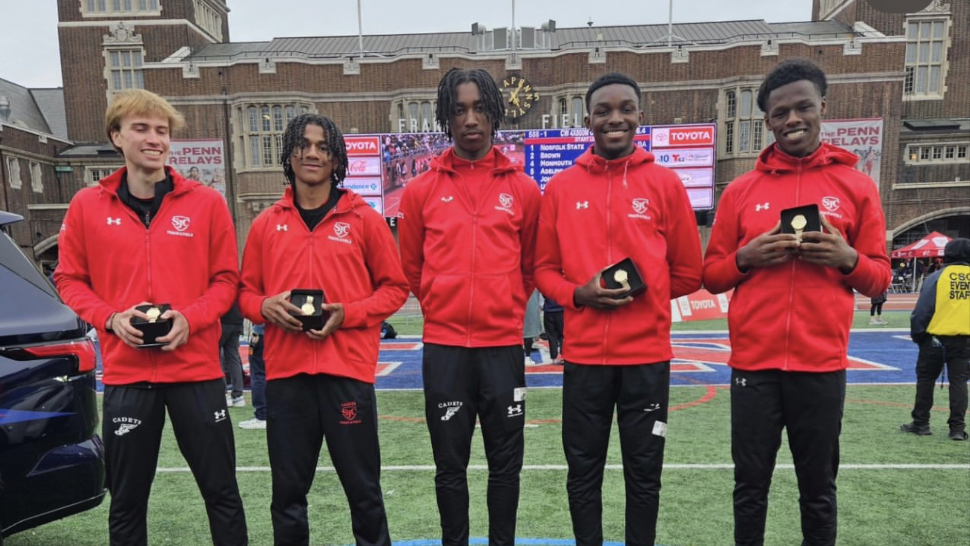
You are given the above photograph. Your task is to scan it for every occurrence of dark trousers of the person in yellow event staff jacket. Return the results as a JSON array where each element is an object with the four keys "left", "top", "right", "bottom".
[{"left": 913, "top": 336, "right": 970, "bottom": 432}]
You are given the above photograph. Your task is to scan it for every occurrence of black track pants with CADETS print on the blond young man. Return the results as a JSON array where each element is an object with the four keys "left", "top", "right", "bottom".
[{"left": 102, "top": 379, "right": 247, "bottom": 546}]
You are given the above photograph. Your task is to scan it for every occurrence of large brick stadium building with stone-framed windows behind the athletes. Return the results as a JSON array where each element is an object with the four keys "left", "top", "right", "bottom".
[{"left": 0, "top": 0, "right": 970, "bottom": 265}]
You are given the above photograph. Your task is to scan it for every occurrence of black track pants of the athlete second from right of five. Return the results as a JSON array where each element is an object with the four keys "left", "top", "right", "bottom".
[{"left": 562, "top": 362, "right": 670, "bottom": 546}]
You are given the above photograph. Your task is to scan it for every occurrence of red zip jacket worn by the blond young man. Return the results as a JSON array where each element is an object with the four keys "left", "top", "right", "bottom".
[{"left": 54, "top": 168, "right": 239, "bottom": 385}]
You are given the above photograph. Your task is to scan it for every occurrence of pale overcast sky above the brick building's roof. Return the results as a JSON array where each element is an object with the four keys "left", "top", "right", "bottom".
[{"left": 0, "top": 0, "right": 812, "bottom": 87}]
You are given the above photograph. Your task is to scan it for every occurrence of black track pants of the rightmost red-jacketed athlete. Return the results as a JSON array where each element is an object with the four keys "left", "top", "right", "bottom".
[{"left": 731, "top": 370, "right": 845, "bottom": 546}]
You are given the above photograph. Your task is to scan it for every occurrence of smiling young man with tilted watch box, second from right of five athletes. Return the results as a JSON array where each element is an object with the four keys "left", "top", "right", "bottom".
[{"left": 536, "top": 72, "right": 701, "bottom": 546}]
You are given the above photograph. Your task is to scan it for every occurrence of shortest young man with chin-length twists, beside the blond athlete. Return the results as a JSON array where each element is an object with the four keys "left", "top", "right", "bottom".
[{"left": 239, "top": 114, "right": 407, "bottom": 546}]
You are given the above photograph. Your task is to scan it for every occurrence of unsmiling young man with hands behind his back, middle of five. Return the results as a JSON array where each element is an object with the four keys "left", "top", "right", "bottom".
[{"left": 398, "top": 68, "right": 540, "bottom": 546}]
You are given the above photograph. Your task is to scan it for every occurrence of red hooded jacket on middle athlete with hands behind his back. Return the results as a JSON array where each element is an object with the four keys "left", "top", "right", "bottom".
[{"left": 398, "top": 146, "right": 541, "bottom": 347}]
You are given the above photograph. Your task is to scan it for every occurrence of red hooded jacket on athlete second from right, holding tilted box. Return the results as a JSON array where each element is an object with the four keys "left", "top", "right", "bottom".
[{"left": 536, "top": 148, "right": 701, "bottom": 365}]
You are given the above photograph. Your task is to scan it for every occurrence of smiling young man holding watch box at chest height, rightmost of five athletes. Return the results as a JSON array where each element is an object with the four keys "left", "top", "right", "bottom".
[{"left": 704, "top": 58, "right": 891, "bottom": 546}]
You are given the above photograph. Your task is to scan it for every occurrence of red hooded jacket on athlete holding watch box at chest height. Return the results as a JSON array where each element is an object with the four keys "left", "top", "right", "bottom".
[{"left": 704, "top": 143, "right": 891, "bottom": 372}]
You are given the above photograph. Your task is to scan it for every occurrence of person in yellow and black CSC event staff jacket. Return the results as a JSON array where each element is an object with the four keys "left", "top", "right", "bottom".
[{"left": 899, "top": 239, "right": 970, "bottom": 440}]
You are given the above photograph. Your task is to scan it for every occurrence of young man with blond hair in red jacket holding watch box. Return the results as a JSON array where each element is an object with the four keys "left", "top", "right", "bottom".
[{"left": 54, "top": 89, "right": 247, "bottom": 546}]
